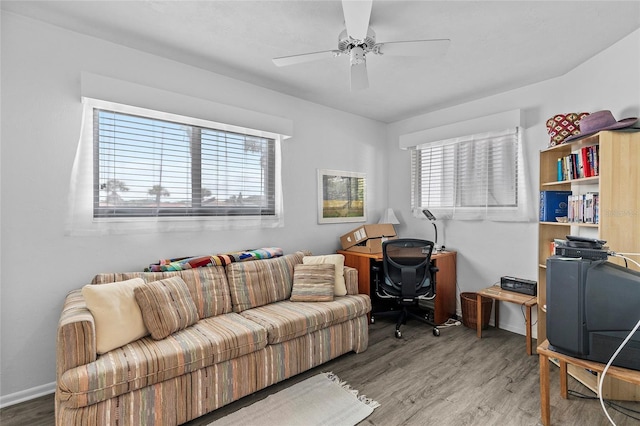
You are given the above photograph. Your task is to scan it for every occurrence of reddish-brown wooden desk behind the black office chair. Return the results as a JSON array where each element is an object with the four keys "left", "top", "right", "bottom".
[{"left": 338, "top": 250, "right": 456, "bottom": 324}]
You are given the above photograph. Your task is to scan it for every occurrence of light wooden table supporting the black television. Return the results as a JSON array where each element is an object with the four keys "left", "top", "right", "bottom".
[{"left": 538, "top": 340, "right": 640, "bottom": 426}]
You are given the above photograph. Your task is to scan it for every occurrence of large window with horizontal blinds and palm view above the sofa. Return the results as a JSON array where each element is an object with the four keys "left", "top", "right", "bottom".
[{"left": 93, "top": 108, "right": 276, "bottom": 218}]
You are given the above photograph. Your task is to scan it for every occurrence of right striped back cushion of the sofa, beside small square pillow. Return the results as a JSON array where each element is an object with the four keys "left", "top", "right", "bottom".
[{"left": 227, "top": 252, "right": 304, "bottom": 312}]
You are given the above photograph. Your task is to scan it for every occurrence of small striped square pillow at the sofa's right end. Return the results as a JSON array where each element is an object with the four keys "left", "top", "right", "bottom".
[{"left": 289, "top": 264, "right": 335, "bottom": 302}]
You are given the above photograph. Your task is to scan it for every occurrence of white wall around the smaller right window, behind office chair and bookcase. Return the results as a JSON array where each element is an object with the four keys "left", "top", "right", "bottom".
[{"left": 387, "top": 30, "right": 640, "bottom": 335}]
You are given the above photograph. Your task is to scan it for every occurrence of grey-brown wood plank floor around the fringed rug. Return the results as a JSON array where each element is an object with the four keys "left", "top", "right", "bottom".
[{"left": 0, "top": 318, "right": 640, "bottom": 426}]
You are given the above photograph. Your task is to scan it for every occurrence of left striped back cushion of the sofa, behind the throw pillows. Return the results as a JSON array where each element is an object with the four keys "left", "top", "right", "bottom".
[{"left": 92, "top": 266, "right": 231, "bottom": 318}]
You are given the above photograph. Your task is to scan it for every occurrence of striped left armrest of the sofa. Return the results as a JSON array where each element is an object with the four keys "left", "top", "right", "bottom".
[{"left": 56, "top": 290, "right": 98, "bottom": 379}]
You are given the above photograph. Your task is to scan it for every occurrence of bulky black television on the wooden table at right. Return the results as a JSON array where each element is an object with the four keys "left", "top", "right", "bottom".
[{"left": 546, "top": 256, "right": 640, "bottom": 370}]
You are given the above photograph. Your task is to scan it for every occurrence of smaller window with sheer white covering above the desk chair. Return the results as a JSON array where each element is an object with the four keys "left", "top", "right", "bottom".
[{"left": 411, "top": 128, "right": 526, "bottom": 220}]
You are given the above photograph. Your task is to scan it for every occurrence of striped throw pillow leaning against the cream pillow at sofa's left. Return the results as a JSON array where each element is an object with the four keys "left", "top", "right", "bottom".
[{"left": 134, "top": 277, "right": 198, "bottom": 340}]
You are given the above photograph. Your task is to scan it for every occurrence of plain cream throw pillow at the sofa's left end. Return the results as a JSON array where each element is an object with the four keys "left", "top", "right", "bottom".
[{"left": 82, "top": 278, "right": 149, "bottom": 354}]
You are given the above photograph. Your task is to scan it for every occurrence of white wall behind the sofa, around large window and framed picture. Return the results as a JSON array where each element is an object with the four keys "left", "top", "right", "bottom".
[{"left": 0, "top": 13, "right": 386, "bottom": 404}]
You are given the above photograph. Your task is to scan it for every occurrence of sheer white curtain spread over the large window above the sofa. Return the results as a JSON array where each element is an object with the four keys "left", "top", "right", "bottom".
[{"left": 66, "top": 97, "right": 287, "bottom": 235}]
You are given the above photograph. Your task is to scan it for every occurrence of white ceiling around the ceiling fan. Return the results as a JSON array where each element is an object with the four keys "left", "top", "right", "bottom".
[{"left": 2, "top": 0, "right": 640, "bottom": 122}]
